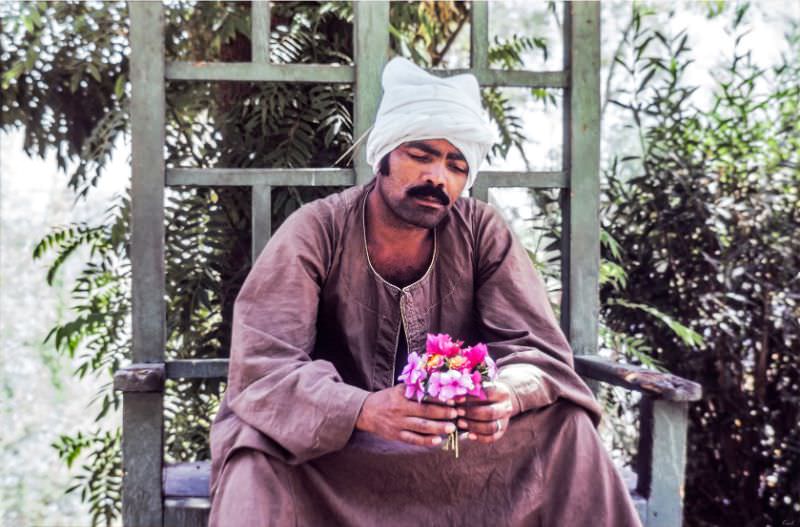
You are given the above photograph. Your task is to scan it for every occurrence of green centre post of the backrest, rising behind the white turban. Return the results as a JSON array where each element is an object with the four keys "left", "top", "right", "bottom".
[{"left": 353, "top": 1, "right": 389, "bottom": 184}]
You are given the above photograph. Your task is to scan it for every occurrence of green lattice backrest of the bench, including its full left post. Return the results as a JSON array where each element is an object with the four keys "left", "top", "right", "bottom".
[{"left": 123, "top": 1, "right": 600, "bottom": 526}]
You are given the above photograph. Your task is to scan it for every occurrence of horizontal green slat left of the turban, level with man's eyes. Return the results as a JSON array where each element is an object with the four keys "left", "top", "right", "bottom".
[{"left": 167, "top": 168, "right": 355, "bottom": 187}]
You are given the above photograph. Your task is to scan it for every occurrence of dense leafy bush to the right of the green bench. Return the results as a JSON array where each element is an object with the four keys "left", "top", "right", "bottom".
[{"left": 603, "top": 4, "right": 800, "bottom": 526}]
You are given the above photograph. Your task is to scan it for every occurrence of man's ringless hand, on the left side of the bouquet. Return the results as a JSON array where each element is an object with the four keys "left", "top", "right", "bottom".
[{"left": 356, "top": 384, "right": 457, "bottom": 446}]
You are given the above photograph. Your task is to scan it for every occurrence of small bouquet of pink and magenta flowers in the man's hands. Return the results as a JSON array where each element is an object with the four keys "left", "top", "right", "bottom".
[{"left": 398, "top": 333, "right": 497, "bottom": 457}]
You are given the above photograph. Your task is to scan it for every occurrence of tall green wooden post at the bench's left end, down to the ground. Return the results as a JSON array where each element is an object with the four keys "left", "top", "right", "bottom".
[{"left": 122, "top": 2, "right": 166, "bottom": 527}]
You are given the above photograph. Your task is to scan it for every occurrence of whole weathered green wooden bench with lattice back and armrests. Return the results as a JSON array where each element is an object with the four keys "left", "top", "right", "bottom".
[{"left": 119, "top": 0, "right": 701, "bottom": 527}]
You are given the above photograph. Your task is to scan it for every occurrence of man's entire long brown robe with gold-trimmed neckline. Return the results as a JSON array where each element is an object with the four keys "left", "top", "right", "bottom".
[{"left": 210, "top": 181, "right": 640, "bottom": 527}]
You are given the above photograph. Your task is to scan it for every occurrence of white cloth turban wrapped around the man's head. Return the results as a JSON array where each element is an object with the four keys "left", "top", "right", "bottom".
[{"left": 367, "top": 57, "right": 494, "bottom": 188}]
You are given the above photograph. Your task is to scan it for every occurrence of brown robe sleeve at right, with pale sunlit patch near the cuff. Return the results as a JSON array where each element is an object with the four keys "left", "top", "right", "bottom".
[{"left": 474, "top": 206, "right": 602, "bottom": 426}]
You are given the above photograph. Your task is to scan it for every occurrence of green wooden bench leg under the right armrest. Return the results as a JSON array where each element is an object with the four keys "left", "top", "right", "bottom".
[{"left": 637, "top": 397, "right": 689, "bottom": 527}]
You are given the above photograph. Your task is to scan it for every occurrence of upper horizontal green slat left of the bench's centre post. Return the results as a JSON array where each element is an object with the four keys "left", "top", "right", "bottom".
[{"left": 166, "top": 62, "right": 356, "bottom": 84}]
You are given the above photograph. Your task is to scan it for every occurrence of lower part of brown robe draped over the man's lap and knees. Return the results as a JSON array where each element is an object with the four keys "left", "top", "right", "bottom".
[{"left": 210, "top": 399, "right": 641, "bottom": 527}]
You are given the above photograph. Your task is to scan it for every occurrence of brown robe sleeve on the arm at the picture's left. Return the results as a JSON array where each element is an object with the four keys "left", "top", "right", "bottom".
[{"left": 227, "top": 203, "right": 369, "bottom": 464}]
